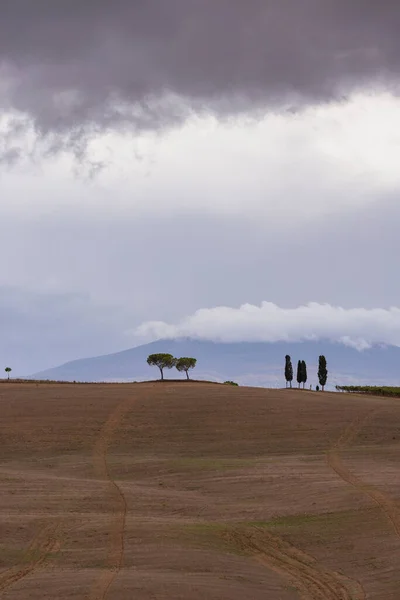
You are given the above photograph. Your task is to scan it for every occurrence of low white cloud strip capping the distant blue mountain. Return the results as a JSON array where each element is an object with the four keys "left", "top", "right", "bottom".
[{"left": 134, "top": 302, "right": 400, "bottom": 350}]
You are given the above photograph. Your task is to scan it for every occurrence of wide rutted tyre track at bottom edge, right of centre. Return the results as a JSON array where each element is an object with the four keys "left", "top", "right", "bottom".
[{"left": 229, "top": 527, "right": 366, "bottom": 600}]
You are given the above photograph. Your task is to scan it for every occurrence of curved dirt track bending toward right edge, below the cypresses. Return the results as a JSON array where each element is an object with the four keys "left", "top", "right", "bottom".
[{"left": 327, "top": 409, "right": 400, "bottom": 538}]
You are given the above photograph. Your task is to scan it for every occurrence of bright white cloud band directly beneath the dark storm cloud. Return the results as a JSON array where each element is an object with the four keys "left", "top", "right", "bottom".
[{"left": 0, "top": 92, "right": 400, "bottom": 224}]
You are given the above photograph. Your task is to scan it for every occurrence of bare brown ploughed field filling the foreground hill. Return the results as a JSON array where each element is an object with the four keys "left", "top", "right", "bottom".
[{"left": 0, "top": 382, "right": 400, "bottom": 600}]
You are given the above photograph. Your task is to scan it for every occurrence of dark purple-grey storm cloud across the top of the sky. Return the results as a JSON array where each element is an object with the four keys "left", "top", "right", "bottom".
[{"left": 0, "top": 0, "right": 400, "bottom": 136}]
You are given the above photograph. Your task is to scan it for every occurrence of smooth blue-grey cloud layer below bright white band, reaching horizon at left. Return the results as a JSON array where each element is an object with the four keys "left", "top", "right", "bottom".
[{"left": 0, "top": 198, "right": 400, "bottom": 373}]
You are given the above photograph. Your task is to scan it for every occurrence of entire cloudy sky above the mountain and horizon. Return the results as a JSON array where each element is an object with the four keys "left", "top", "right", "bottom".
[{"left": 0, "top": 0, "right": 400, "bottom": 374}]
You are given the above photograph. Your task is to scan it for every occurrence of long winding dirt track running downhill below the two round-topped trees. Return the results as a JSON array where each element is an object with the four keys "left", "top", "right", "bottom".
[{"left": 88, "top": 401, "right": 132, "bottom": 600}]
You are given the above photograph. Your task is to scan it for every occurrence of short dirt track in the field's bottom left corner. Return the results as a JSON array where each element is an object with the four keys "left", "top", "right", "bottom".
[{"left": 0, "top": 522, "right": 61, "bottom": 596}]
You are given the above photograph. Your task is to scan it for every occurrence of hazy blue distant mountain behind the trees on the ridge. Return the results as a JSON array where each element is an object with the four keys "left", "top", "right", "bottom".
[{"left": 32, "top": 338, "right": 400, "bottom": 389}]
